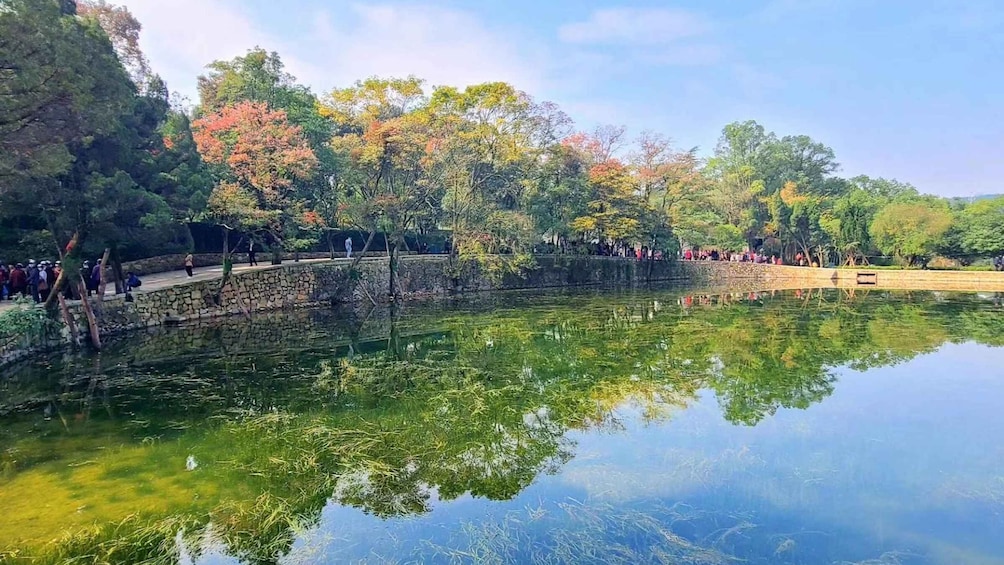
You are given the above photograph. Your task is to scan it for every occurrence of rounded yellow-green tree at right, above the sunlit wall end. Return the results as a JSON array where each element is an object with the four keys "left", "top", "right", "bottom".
[{"left": 868, "top": 200, "right": 952, "bottom": 265}]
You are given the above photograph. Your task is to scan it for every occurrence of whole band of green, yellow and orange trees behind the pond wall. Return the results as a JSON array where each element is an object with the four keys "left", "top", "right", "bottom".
[{"left": 0, "top": 5, "right": 1004, "bottom": 297}]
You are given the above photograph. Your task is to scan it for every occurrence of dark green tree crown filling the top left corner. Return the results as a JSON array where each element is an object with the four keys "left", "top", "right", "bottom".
[{"left": 0, "top": 0, "right": 130, "bottom": 191}]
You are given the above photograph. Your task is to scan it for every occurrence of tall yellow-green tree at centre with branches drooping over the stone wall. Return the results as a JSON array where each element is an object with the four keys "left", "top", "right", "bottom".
[{"left": 428, "top": 82, "right": 543, "bottom": 278}]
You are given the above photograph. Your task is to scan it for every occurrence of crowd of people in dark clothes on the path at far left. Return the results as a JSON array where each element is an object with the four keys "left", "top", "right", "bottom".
[{"left": 0, "top": 259, "right": 143, "bottom": 303}]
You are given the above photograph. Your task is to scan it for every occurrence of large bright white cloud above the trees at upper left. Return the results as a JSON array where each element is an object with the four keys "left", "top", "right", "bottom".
[{"left": 121, "top": 0, "right": 546, "bottom": 101}]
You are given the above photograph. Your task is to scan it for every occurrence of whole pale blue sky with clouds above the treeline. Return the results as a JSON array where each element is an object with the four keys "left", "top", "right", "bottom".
[{"left": 119, "top": 0, "right": 1004, "bottom": 196}]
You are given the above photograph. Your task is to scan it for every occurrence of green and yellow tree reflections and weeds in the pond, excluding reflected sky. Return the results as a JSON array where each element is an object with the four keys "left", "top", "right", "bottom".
[{"left": 0, "top": 290, "right": 1004, "bottom": 562}]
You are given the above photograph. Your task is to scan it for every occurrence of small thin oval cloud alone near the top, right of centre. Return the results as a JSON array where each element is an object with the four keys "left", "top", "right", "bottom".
[{"left": 558, "top": 8, "right": 712, "bottom": 45}]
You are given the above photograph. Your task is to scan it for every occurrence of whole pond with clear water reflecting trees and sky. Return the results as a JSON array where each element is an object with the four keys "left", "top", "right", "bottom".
[{"left": 0, "top": 290, "right": 1004, "bottom": 564}]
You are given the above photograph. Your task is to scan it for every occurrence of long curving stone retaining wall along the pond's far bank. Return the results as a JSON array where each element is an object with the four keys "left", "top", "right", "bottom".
[{"left": 0, "top": 255, "right": 1004, "bottom": 365}]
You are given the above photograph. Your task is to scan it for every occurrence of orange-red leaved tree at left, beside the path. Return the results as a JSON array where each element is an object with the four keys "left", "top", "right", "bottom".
[{"left": 193, "top": 102, "right": 317, "bottom": 274}]
